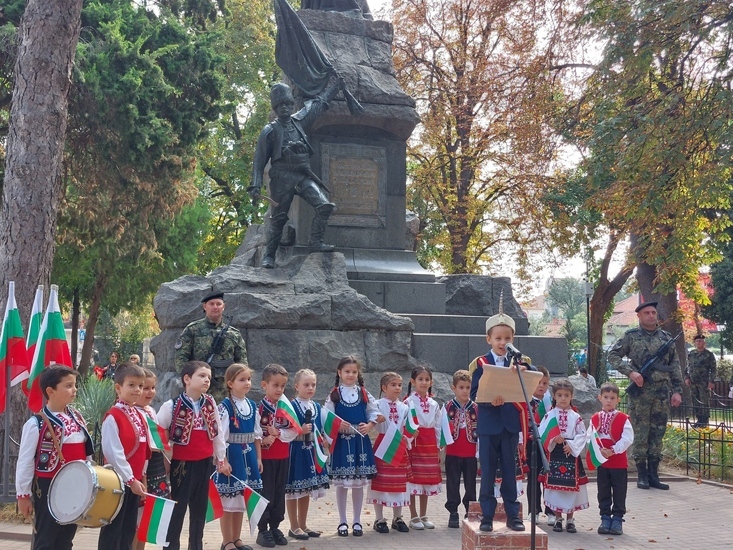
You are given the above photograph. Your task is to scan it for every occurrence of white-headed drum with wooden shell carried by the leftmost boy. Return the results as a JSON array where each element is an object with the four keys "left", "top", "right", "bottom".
[{"left": 48, "top": 460, "right": 125, "bottom": 527}]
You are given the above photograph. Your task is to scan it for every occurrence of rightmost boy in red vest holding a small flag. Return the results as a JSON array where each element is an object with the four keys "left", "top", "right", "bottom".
[{"left": 587, "top": 382, "right": 634, "bottom": 535}]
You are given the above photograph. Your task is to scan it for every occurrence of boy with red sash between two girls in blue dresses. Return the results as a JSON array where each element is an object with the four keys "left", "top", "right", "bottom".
[{"left": 257, "top": 363, "right": 298, "bottom": 548}]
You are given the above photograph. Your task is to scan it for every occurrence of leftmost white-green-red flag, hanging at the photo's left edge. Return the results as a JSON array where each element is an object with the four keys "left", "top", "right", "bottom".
[{"left": 0, "top": 281, "right": 30, "bottom": 413}]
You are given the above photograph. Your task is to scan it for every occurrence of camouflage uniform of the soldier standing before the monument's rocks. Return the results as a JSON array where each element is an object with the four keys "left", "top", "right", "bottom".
[{"left": 176, "top": 317, "right": 247, "bottom": 401}]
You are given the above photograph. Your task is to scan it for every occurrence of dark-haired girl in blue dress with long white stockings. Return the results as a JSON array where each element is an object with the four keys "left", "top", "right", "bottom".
[{"left": 325, "top": 356, "right": 384, "bottom": 537}]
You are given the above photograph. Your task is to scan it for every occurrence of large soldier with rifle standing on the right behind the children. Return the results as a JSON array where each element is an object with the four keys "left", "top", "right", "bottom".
[{"left": 608, "top": 302, "right": 682, "bottom": 489}]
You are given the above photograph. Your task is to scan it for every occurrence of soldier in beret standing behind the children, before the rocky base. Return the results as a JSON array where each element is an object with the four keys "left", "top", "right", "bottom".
[{"left": 176, "top": 292, "right": 247, "bottom": 401}]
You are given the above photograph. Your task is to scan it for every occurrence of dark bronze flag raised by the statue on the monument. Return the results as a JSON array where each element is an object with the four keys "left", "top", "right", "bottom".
[{"left": 275, "top": 0, "right": 364, "bottom": 114}]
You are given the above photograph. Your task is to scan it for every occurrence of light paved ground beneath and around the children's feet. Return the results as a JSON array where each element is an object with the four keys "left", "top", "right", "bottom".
[{"left": 0, "top": 480, "right": 733, "bottom": 550}]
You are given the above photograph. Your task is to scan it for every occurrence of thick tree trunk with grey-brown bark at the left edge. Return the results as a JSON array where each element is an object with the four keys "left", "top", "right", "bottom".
[{"left": 0, "top": 0, "right": 82, "bottom": 492}]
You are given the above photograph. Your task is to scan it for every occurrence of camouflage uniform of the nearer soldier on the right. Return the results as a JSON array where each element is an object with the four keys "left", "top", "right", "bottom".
[{"left": 608, "top": 327, "right": 682, "bottom": 466}]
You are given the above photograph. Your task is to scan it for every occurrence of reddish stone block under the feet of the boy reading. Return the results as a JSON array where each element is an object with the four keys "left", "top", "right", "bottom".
[{"left": 461, "top": 502, "right": 548, "bottom": 550}]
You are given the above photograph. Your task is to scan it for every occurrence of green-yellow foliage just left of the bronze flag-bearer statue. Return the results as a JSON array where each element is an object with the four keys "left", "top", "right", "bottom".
[{"left": 197, "top": 0, "right": 280, "bottom": 272}]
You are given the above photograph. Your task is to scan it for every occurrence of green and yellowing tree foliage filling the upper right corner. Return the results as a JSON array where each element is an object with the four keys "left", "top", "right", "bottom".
[{"left": 550, "top": 0, "right": 733, "bottom": 376}]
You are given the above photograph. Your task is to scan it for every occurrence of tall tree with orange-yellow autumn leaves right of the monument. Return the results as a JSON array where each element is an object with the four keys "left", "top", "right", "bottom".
[{"left": 392, "top": 0, "right": 568, "bottom": 273}]
